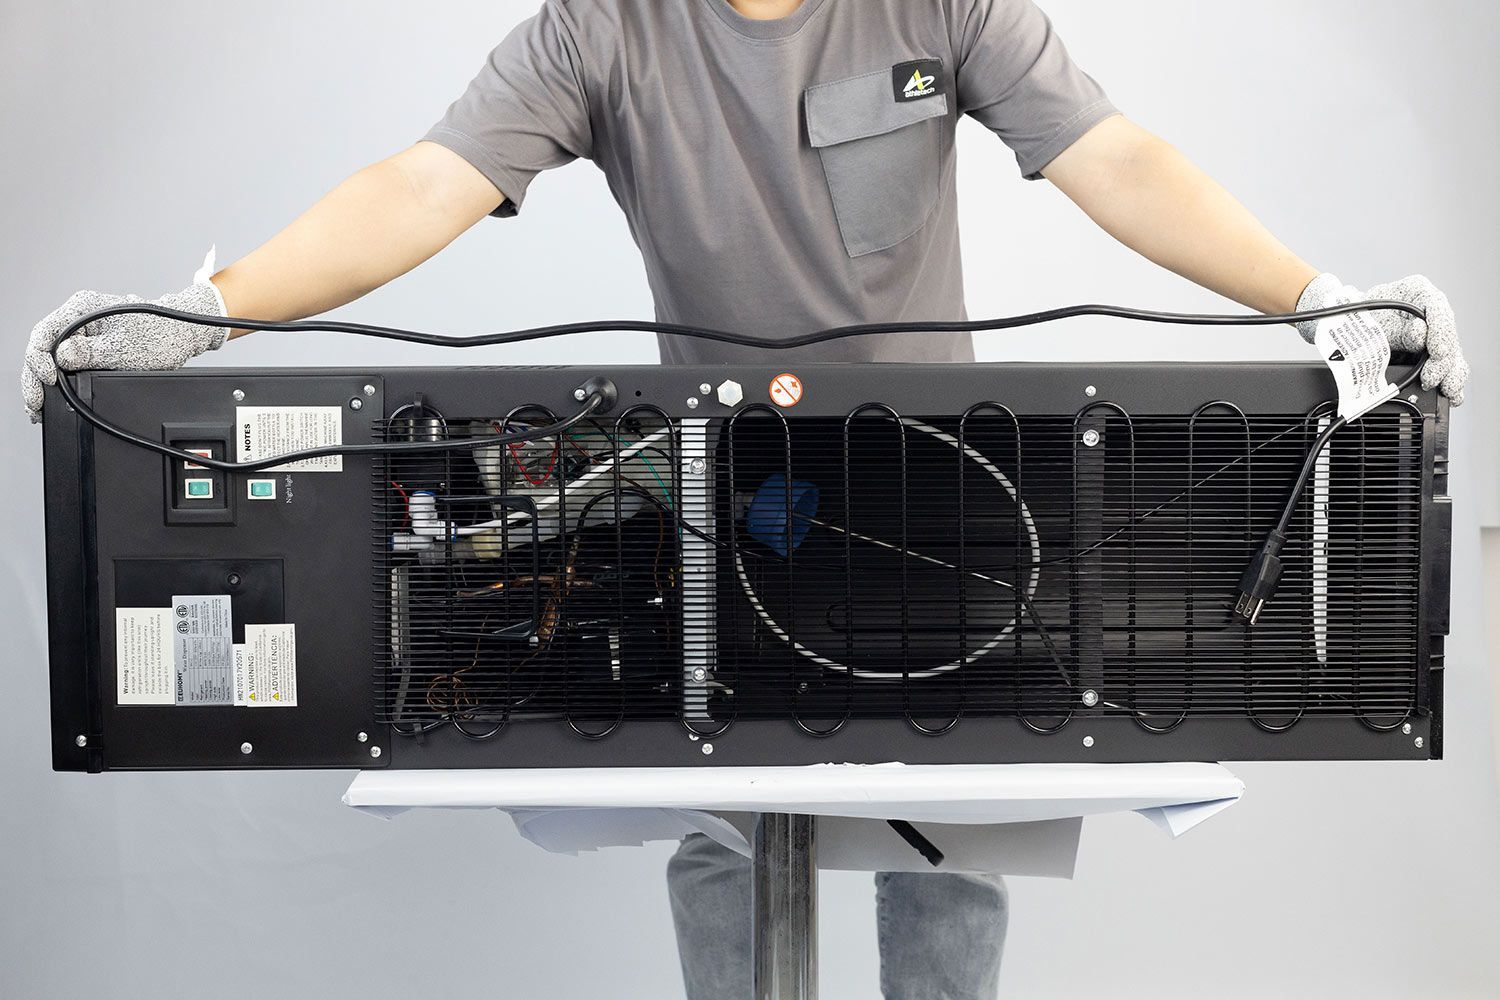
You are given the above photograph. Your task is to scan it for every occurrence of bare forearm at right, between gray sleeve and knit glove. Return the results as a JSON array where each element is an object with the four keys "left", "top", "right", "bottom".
[{"left": 1043, "top": 117, "right": 1317, "bottom": 313}]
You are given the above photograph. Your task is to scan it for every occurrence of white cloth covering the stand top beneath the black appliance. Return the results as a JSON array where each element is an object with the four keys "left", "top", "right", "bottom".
[{"left": 344, "top": 763, "right": 1245, "bottom": 879}]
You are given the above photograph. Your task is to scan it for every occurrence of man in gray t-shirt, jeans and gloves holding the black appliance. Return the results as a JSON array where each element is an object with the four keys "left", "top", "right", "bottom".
[{"left": 23, "top": 0, "right": 1469, "bottom": 1000}]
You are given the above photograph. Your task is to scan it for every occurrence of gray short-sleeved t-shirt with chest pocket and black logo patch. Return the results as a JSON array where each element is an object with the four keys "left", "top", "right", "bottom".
[{"left": 426, "top": 0, "right": 1115, "bottom": 363}]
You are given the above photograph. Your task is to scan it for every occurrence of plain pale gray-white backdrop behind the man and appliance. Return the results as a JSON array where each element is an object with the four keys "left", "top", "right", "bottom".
[{"left": 0, "top": 0, "right": 1500, "bottom": 1000}]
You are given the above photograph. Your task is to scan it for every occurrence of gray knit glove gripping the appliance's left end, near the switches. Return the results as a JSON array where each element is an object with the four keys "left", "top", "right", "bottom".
[{"left": 21, "top": 280, "right": 230, "bottom": 423}]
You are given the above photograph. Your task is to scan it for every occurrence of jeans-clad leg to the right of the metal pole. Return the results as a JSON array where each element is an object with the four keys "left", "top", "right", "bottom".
[{"left": 875, "top": 871, "right": 1010, "bottom": 1000}]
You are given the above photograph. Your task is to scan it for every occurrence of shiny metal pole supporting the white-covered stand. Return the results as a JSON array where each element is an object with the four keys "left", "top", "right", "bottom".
[{"left": 750, "top": 813, "right": 818, "bottom": 1000}]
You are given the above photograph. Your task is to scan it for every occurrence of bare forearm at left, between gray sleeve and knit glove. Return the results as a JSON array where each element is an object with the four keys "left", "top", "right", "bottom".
[{"left": 213, "top": 142, "right": 504, "bottom": 336}]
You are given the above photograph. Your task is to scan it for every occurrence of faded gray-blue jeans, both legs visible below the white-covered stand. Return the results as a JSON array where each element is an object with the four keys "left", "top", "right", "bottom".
[{"left": 666, "top": 834, "right": 1010, "bottom": 1000}]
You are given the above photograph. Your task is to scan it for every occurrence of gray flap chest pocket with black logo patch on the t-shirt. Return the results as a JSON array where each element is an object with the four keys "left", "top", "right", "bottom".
[{"left": 803, "top": 60, "right": 948, "bottom": 256}]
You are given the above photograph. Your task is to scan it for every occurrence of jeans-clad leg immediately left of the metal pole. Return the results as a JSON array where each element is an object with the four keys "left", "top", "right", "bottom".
[{"left": 666, "top": 834, "right": 752, "bottom": 1000}]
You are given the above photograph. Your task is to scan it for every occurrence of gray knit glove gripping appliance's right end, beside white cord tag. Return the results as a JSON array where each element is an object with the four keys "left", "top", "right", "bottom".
[{"left": 1298, "top": 274, "right": 1469, "bottom": 406}]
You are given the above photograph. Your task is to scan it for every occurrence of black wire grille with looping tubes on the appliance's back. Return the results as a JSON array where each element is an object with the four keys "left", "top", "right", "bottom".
[{"left": 374, "top": 403, "right": 1425, "bottom": 738}]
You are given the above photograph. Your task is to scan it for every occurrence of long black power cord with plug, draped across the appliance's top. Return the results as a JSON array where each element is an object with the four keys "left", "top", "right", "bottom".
[{"left": 53, "top": 300, "right": 1427, "bottom": 625}]
